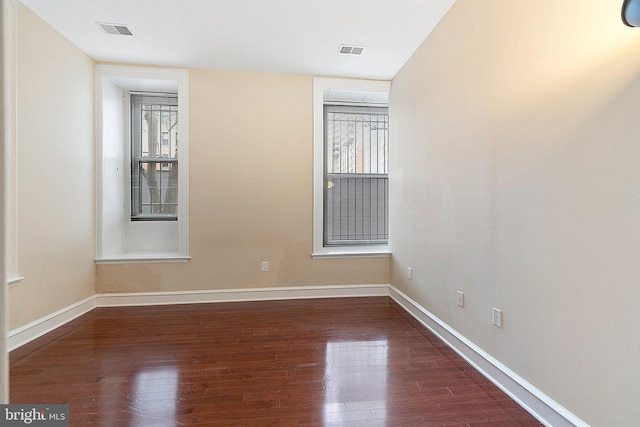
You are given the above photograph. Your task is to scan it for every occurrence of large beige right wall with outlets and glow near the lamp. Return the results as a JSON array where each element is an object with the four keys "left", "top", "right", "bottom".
[{"left": 390, "top": 0, "right": 640, "bottom": 426}]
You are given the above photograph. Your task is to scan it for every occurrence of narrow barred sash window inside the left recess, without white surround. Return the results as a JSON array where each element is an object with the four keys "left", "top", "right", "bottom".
[{"left": 131, "top": 93, "right": 179, "bottom": 221}]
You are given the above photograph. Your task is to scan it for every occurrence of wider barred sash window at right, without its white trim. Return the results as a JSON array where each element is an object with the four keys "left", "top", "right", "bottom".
[{"left": 323, "top": 105, "right": 389, "bottom": 246}]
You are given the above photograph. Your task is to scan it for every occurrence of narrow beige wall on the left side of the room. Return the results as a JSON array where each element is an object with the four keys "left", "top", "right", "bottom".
[{"left": 9, "top": 5, "right": 95, "bottom": 328}]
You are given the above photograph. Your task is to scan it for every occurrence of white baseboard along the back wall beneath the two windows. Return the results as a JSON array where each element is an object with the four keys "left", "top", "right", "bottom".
[{"left": 96, "top": 285, "right": 389, "bottom": 307}]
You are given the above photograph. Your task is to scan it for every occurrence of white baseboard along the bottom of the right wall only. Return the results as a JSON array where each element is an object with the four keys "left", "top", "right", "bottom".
[{"left": 389, "top": 286, "right": 589, "bottom": 427}]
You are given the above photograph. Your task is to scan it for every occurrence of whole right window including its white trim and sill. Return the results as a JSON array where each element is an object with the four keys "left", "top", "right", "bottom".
[{"left": 312, "top": 78, "right": 390, "bottom": 258}]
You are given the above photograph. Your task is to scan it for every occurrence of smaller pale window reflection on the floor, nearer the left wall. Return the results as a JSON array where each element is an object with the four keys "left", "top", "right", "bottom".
[{"left": 128, "top": 367, "right": 178, "bottom": 425}]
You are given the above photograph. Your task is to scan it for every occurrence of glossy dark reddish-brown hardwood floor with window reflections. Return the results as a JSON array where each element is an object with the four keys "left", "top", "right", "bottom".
[{"left": 10, "top": 297, "right": 540, "bottom": 427}]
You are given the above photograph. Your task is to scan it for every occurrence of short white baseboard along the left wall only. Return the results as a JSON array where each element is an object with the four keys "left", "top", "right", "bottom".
[{"left": 7, "top": 295, "right": 96, "bottom": 351}]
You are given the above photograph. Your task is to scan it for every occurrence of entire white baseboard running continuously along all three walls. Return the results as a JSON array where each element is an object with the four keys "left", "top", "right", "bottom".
[{"left": 7, "top": 285, "right": 589, "bottom": 427}]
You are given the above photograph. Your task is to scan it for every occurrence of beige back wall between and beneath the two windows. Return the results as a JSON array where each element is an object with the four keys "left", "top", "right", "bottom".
[{"left": 97, "top": 69, "right": 389, "bottom": 292}]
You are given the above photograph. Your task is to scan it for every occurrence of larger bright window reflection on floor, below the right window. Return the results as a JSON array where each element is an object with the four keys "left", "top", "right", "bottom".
[{"left": 322, "top": 340, "right": 389, "bottom": 425}]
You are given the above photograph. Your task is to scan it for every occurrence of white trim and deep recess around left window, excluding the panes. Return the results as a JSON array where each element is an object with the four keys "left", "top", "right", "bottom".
[{"left": 95, "top": 64, "right": 189, "bottom": 264}]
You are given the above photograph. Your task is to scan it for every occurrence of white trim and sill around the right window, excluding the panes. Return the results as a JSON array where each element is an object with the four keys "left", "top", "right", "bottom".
[{"left": 311, "top": 78, "right": 391, "bottom": 258}]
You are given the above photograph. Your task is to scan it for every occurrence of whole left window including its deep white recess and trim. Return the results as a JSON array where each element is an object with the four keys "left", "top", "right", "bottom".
[{"left": 96, "top": 64, "right": 189, "bottom": 263}]
